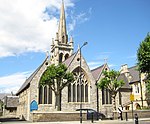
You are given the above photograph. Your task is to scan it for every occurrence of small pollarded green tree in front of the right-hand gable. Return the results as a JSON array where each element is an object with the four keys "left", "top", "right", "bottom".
[{"left": 97, "top": 70, "right": 124, "bottom": 110}]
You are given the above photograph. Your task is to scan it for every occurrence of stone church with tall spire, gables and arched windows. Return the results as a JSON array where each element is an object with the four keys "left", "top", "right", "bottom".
[{"left": 16, "top": 3, "right": 129, "bottom": 120}]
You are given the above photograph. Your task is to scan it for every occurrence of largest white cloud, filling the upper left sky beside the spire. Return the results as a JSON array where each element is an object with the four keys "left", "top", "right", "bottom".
[{"left": 0, "top": 0, "right": 74, "bottom": 57}]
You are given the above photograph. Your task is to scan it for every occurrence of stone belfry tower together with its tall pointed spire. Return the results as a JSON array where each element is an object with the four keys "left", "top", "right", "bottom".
[{"left": 50, "top": 0, "right": 74, "bottom": 65}]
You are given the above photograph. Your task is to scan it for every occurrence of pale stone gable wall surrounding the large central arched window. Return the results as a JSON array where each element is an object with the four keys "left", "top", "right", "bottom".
[{"left": 62, "top": 52, "right": 97, "bottom": 111}]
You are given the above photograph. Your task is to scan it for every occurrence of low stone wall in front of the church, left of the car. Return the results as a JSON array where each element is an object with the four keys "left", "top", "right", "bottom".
[{"left": 32, "top": 112, "right": 87, "bottom": 122}]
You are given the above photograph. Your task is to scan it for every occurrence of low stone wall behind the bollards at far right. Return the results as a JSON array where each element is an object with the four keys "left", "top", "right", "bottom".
[{"left": 114, "top": 110, "right": 150, "bottom": 119}]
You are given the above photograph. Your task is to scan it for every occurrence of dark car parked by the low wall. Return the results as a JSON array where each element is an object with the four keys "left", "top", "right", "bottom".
[{"left": 76, "top": 109, "right": 105, "bottom": 120}]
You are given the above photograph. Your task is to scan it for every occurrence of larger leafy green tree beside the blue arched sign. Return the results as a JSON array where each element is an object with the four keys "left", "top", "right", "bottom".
[{"left": 40, "top": 63, "right": 74, "bottom": 111}]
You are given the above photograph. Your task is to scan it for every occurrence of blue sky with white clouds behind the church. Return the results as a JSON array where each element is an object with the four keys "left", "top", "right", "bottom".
[{"left": 0, "top": 0, "right": 150, "bottom": 93}]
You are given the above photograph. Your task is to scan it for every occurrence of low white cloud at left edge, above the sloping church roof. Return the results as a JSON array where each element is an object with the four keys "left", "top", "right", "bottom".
[{"left": 0, "top": 71, "right": 31, "bottom": 93}]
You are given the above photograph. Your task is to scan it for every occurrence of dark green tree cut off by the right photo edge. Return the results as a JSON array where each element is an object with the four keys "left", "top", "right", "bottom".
[{"left": 137, "top": 33, "right": 150, "bottom": 93}]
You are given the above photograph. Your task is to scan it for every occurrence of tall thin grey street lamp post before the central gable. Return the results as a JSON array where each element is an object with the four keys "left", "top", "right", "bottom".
[{"left": 80, "top": 42, "right": 88, "bottom": 123}]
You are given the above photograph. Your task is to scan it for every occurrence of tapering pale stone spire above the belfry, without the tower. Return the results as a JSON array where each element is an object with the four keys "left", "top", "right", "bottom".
[{"left": 58, "top": 0, "right": 68, "bottom": 44}]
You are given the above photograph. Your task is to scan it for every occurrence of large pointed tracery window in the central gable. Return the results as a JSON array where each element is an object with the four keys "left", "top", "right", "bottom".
[{"left": 68, "top": 67, "right": 89, "bottom": 102}]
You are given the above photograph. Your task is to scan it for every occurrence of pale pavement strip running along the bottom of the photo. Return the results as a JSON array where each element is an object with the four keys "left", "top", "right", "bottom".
[{"left": 0, "top": 118, "right": 150, "bottom": 124}]
